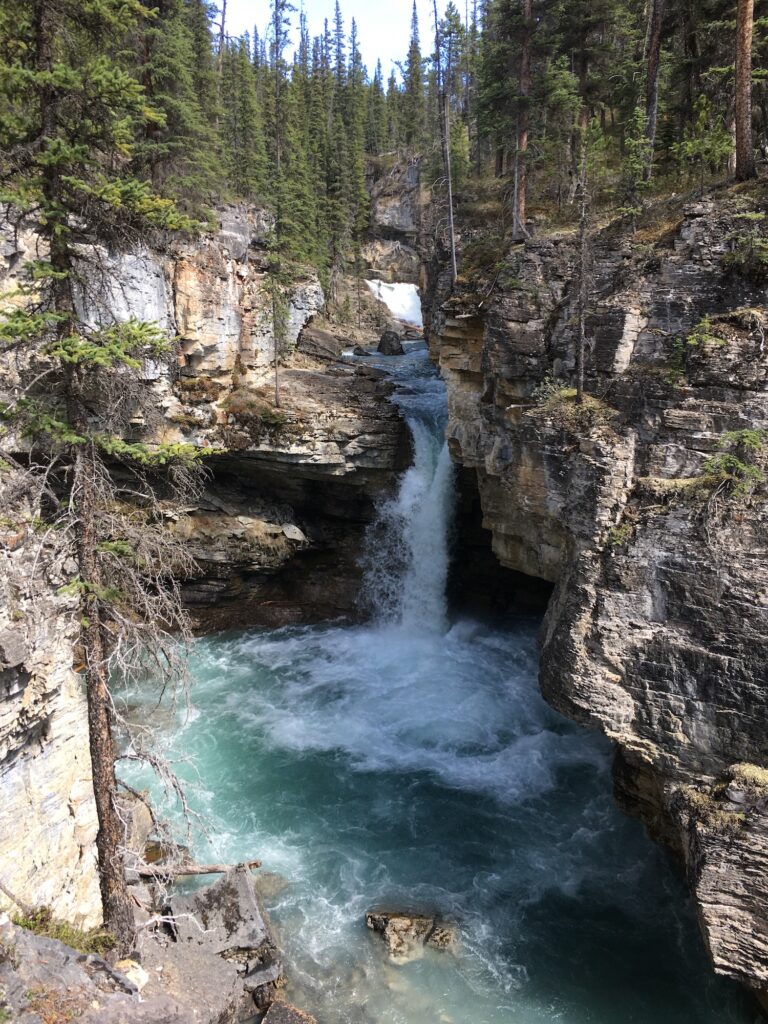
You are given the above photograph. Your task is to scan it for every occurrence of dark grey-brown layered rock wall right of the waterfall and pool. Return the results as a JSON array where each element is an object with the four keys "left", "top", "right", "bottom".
[{"left": 431, "top": 194, "right": 768, "bottom": 990}]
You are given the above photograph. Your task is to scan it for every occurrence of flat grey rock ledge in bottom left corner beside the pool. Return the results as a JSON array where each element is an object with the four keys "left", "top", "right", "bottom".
[{"left": 0, "top": 867, "right": 284, "bottom": 1024}]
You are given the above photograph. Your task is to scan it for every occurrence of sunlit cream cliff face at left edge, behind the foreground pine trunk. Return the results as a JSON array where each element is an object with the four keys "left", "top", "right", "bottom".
[{"left": 0, "top": 495, "right": 101, "bottom": 928}]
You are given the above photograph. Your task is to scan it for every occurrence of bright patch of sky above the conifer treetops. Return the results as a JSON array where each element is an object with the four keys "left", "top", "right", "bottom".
[{"left": 226, "top": 0, "right": 450, "bottom": 77}]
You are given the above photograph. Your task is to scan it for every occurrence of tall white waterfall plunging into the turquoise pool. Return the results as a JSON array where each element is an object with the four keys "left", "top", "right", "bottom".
[{"left": 364, "top": 359, "right": 455, "bottom": 633}]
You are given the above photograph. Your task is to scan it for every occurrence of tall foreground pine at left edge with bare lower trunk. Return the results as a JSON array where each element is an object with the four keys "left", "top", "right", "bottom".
[{"left": 0, "top": 0, "right": 202, "bottom": 952}]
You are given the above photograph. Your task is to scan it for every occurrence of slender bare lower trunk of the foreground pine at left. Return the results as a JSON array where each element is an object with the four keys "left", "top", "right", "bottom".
[{"left": 73, "top": 445, "right": 135, "bottom": 953}]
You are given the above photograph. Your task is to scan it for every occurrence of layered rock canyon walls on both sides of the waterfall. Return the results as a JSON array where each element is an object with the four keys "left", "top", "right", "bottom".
[{"left": 0, "top": 162, "right": 768, "bottom": 1015}]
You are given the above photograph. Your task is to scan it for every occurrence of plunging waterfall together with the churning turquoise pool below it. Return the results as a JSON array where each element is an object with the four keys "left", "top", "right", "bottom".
[{"left": 129, "top": 342, "right": 753, "bottom": 1024}]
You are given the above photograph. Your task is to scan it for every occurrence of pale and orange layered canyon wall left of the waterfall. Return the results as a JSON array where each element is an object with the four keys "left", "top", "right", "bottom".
[{"left": 0, "top": 201, "right": 410, "bottom": 926}]
